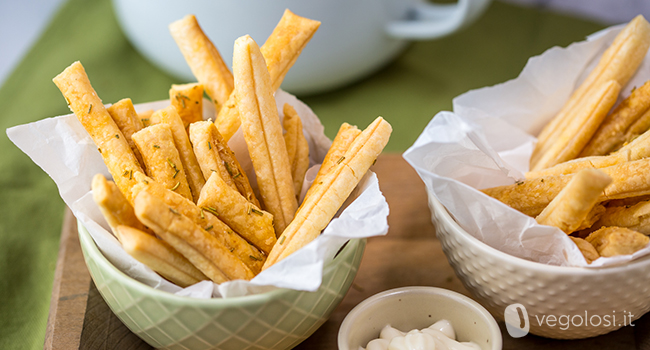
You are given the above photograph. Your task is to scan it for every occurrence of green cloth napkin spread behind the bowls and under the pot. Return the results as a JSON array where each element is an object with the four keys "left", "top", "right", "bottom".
[{"left": 0, "top": 0, "right": 603, "bottom": 349}]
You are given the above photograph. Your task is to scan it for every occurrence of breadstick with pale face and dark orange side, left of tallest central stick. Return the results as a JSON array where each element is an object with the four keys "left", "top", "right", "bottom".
[{"left": 190, "top": 121, "right": 260, "bottom": 207}]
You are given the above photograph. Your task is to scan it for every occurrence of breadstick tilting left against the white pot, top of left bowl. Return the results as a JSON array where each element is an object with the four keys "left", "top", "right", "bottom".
[{"left": 169, "top": 15, "right": 233, "bottom": 111}]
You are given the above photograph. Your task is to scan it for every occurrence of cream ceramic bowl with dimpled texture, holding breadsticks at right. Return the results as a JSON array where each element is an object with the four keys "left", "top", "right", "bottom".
[{"left": 428, "top": 192, "right": 650, "bottom": 339}]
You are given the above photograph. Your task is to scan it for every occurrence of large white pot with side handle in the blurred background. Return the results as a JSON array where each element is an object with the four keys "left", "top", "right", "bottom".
[{"left": 113, "top": 0, "right": 491, "bottom": 94}]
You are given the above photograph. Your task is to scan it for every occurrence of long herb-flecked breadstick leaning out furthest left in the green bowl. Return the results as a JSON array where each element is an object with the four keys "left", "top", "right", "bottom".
[{"left": 53, "top": 62, "right": 142, "bottom": 202}]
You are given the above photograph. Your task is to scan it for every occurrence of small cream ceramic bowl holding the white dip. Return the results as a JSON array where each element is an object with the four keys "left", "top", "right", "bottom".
[{"left": 338, "top": 286, "right": 502, "bottom": 350}]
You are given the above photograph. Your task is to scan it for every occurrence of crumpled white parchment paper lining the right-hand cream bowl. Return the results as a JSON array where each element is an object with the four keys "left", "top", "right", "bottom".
[{"left": 404, "top": 22, "right": 650, "bottom": 267}]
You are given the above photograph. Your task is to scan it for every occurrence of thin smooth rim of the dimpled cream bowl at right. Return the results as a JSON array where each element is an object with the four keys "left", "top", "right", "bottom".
[{"left": 428, "top": 192, "right": 650, "bottom": 275}]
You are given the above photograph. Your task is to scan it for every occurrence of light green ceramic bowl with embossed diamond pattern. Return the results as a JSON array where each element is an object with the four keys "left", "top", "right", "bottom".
[{"left": 78, "top": 224, "right": 366, "bottom": 350}]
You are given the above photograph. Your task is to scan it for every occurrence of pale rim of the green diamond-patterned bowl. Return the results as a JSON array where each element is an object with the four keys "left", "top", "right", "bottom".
[{"left": 77, "top": 220, "right": 363, "bottom": 307}]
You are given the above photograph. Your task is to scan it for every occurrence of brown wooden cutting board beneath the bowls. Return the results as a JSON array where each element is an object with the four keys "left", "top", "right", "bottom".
[{"left": 44, "top": 154, "right": 650, "bottom": 350}]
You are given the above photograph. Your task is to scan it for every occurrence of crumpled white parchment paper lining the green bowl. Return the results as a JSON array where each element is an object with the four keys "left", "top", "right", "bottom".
[{"left": 7, "top": 90, "right": 388, "bottom": 298}]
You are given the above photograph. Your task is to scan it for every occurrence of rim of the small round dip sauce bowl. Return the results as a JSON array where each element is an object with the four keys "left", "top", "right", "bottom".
[{"left": 337, "top": 286, "right": 503, "bottom": 349}]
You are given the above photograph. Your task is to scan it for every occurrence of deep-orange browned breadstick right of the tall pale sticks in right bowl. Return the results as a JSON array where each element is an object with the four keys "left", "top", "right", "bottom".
[{"left": 579, "top": 81, "right": 650, "bottom": 157}]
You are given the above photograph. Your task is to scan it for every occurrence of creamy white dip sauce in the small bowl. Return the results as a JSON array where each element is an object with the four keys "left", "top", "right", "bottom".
[{"left": 359, "top": 320, "right": 481, "bottom": 350}]
